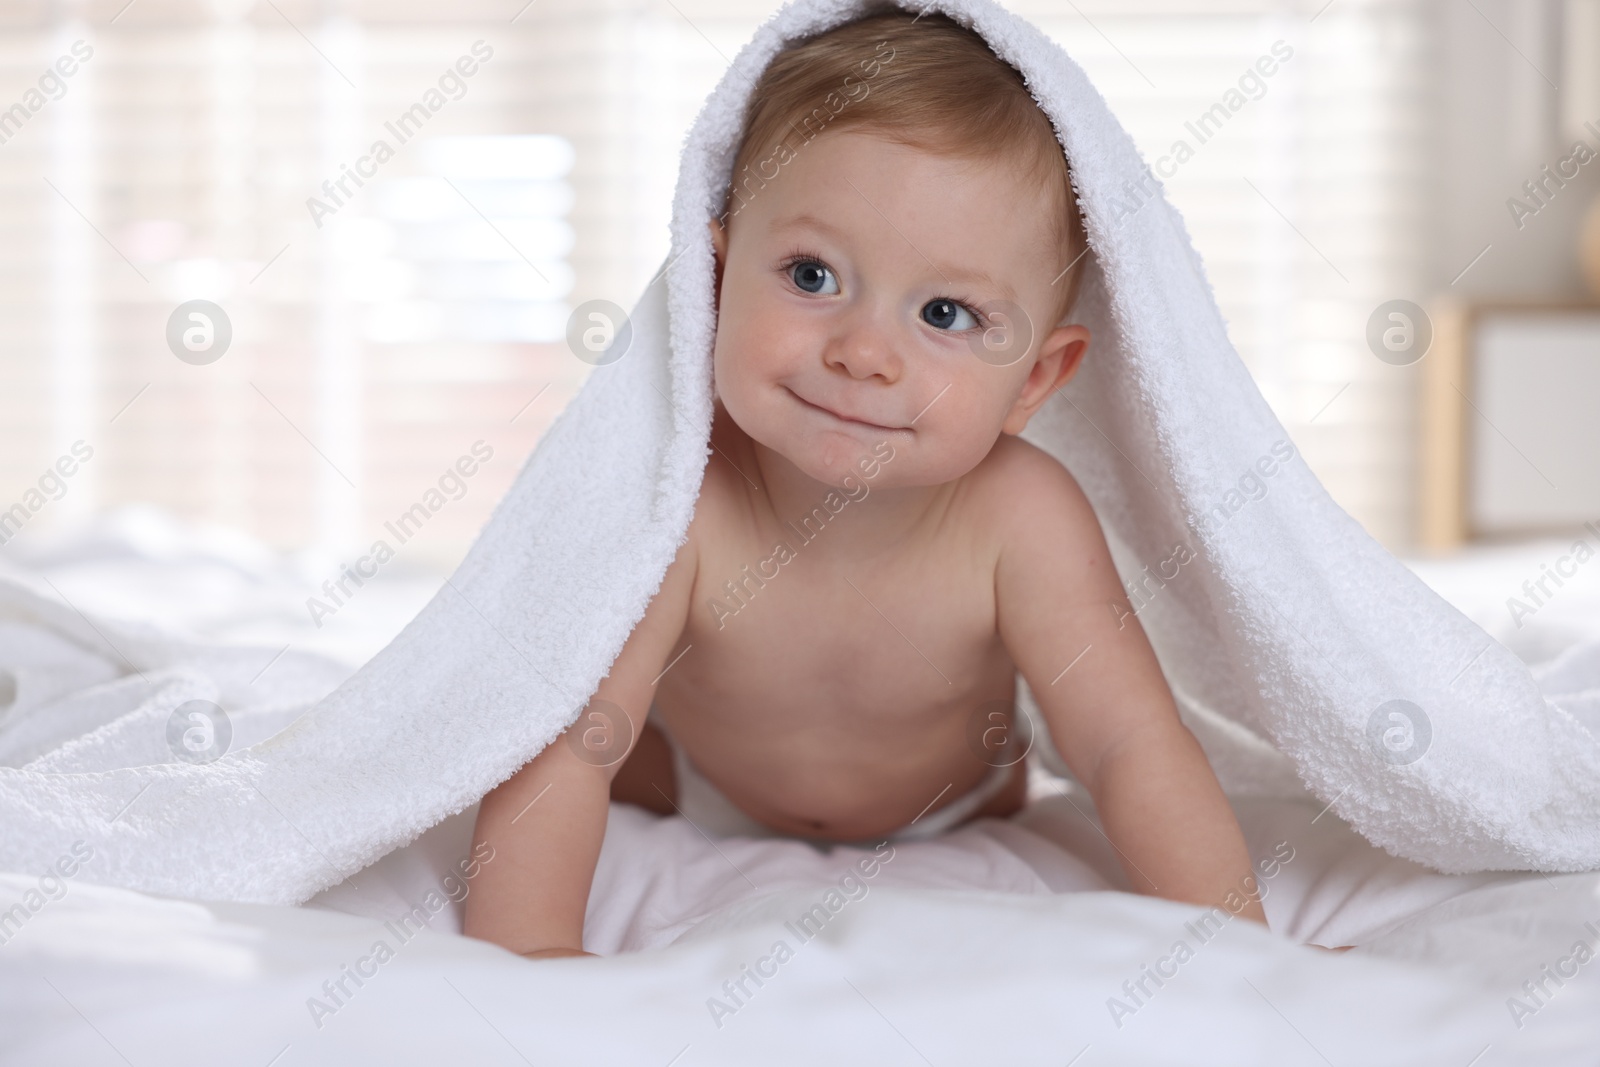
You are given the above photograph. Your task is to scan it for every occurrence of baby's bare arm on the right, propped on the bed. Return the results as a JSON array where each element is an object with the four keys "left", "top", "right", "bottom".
[{"left": 995, "top": 448, "right": 1267, "bottom": 923}]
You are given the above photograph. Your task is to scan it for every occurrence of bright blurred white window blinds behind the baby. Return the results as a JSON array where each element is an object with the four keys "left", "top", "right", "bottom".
[{"left": 0, "top": 0, "right": 1430, "bottom": 565}]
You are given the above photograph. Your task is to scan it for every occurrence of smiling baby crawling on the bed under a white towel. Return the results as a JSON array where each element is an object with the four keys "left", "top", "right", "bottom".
[{"left": 466, "top": 13, "right": 1266, "bottom": 957}]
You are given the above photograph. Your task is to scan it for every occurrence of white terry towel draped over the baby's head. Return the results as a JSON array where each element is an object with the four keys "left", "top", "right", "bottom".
[{"left": 0, "top": 0, "right": 1600, "bottom": 904}]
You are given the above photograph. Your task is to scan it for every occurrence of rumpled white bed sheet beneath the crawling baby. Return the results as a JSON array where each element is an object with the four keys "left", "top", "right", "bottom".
[{"left": 0, "top": 509, "right": 1600, "bottom": 1067}]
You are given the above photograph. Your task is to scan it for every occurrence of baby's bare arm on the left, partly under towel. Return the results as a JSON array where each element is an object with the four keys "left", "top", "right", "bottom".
[{"left": 462, "top": 539, "right": 696, "bottom": 957}]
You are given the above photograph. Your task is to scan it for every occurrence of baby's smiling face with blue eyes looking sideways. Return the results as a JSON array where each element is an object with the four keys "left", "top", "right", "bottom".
[{"left": 710, "top": 130, "right": 1088, "bottom": 485}]
